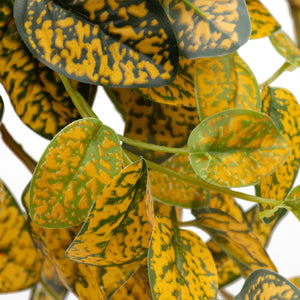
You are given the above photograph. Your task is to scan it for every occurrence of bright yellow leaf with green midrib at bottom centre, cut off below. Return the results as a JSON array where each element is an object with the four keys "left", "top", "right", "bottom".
[{"left": 148, "top": 217, "right": 218, "bottom": 299}]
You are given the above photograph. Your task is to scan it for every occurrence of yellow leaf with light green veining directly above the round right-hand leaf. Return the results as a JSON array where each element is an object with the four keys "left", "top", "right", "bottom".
[{"left": 195, "top": 53, "right": 261, "bottom": 120}]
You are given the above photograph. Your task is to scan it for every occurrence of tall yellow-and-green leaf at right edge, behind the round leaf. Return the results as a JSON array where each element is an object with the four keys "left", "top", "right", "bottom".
[{"left": 255, "top": 86, "right": 300, "bottom": 222}]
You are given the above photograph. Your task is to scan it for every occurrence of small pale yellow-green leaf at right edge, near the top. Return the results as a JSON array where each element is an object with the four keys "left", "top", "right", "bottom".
[{"left": 269, "top": 30, "right": 300, "bottom": 66}]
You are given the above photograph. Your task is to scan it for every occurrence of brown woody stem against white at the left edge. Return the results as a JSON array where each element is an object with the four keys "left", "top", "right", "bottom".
[{"left": 0, "top": 123, "right": 36, "bottom": 173}]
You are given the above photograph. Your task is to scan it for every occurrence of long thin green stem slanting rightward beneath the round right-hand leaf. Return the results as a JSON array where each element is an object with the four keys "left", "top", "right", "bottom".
[{"left": 124, "top": 150, "right": 282, "bottom": 206}]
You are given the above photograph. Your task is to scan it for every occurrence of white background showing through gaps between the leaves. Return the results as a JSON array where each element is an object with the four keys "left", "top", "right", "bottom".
[{"left": 0, "top": 0, "right": 300, "bottom": 300}]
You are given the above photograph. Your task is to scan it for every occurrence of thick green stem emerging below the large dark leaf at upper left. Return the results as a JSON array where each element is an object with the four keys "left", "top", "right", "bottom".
[{"left": 59, "top": 74, "right": 98, "bottom": 118}]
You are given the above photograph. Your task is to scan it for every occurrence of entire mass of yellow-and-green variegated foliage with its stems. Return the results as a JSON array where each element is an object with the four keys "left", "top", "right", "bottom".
[{"left": 0, "top": 0, "right": 300, "bottom": 300}]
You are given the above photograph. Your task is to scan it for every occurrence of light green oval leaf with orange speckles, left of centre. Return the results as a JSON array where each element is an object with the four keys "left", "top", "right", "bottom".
[{"left": 29, "top": 118, "right": 122, "bottom": 228}]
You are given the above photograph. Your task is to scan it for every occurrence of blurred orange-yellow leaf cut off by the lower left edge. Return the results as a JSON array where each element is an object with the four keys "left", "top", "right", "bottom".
[{"left": 0, "top": 182, "right": 42, "bottom": 293}]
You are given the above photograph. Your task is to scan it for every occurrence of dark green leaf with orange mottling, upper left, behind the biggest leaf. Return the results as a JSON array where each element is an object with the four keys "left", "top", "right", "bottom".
[{"left": 0, "top": 0, "right": 96, "bottom": 139}]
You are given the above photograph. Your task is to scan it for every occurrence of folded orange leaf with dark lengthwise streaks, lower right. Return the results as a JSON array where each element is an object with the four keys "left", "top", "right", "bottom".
[{"left": 197, "top": 208, "right": 276, "bottom": 277}]
